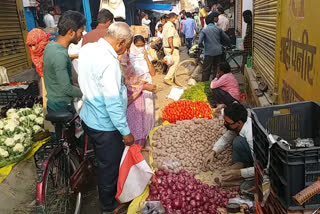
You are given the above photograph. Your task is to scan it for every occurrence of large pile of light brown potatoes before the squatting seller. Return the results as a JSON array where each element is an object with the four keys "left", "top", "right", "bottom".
[{"left": 152, "top": 118, "right": 231, "bottom": 174}]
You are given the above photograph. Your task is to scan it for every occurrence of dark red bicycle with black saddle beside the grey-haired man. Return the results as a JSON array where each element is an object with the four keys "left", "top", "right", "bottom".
[{"left": 35, "top": 112, "right": 95, "bottom": 214}]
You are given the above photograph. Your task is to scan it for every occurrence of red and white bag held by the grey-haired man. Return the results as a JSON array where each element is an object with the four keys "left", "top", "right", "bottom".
[{"left": 116, "top": 145, "right": 153, "bottom": 203}]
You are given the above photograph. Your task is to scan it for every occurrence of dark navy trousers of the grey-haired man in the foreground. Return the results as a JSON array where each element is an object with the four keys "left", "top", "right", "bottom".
[{"left": 84, "top": 124, "right": 125, "bottom": 212}]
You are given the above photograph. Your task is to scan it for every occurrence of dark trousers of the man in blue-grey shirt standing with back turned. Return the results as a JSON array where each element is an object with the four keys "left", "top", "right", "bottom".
[{"left": 202, "top": 55, "right": 222, "bottom": 82}]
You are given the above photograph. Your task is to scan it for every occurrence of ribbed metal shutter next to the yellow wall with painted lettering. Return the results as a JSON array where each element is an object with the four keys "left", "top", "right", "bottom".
[{"left": 253, "top": 0, "right": 278, "bottom": 93}]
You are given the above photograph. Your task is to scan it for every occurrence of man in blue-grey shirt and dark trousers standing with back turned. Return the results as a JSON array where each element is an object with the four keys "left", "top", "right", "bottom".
[{"left": 199, "top": 11, "right": 231, "bottom": 82}]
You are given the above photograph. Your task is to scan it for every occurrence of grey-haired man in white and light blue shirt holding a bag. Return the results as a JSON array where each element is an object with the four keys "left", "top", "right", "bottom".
[{"left": 79, "top": 22, "right": 134, "bottom": 213}]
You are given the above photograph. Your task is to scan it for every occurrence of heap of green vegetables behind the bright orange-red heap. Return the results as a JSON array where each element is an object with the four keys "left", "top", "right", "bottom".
[{"left": 180, "top": 82, "right": 210, "bottom": 102}]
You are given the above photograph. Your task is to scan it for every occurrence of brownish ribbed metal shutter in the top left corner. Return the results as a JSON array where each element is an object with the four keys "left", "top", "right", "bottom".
[{"left": 0, "top": 0, "right": 30, "bottom": 75}]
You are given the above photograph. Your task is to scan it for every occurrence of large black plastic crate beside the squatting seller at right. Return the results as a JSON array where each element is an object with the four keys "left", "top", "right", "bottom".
[{"left": 253, "top": 102, "right": 320, "bottom": 210}]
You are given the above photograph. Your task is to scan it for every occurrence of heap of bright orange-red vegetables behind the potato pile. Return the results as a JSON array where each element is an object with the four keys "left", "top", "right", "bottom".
[{"left": 162, "top": 100, "right": 213, "bottom": 123}]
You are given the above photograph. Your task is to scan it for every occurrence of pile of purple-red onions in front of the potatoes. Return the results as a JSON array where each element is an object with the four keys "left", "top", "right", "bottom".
[{"left": 148, "top": 170, "right": 239, "bottom": 214}]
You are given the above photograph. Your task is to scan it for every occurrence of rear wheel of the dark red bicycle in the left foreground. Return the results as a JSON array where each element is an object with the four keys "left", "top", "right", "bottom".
[{"left": 44, "top": 150, "right": 81, "bottom": 214}]
